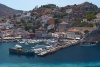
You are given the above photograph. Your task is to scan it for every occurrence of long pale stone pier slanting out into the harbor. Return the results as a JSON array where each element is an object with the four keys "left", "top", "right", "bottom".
[{"left": 37, "top": 40, "right": 79, "bottom": 56}]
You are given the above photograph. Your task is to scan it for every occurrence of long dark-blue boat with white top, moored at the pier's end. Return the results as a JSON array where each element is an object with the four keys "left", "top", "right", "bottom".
[{"left": 9, "top": 45, "right": 35, "bottom": 55}]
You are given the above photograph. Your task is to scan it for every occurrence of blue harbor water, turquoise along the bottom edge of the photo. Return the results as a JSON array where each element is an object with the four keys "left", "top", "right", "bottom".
[{"left": 0, "top": 42, "right": 100, "bottom": 67}]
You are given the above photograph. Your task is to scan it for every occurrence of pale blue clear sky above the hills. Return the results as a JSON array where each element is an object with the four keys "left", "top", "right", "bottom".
[{"left": 0, "top": 0, "right": 100, "bottom": 11}]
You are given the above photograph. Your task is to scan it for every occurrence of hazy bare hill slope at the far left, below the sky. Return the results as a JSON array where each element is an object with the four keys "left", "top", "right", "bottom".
[{"left": 0, "top": 4, "right": 20, "bottom": 16}]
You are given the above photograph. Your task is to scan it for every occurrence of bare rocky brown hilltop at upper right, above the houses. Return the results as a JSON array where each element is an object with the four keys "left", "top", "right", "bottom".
[{"left": 61, "top": 2, "right": 98, "bottom": 13}]
